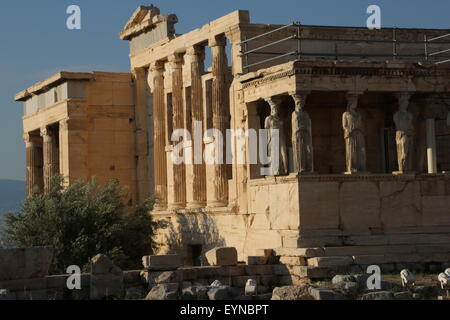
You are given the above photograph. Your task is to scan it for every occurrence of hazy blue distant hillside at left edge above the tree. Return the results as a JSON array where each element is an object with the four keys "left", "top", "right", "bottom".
[{"left": 0, "top": 179, "right": 26, "bottom": 216}]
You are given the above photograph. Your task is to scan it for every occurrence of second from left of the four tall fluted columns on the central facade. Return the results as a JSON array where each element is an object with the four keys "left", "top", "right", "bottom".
[{"left": 169, "top": 54, "right": 186, "bottom": 209}]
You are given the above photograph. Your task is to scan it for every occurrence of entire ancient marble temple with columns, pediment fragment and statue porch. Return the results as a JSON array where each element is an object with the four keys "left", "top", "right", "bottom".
[{"left": 15, "top": 6, "right": 450, "bottom": 272}]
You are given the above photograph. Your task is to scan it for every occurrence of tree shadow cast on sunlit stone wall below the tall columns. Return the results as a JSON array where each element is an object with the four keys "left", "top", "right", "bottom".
[{"left": 157, "top": 213, "right": 225, "bottom": 266}]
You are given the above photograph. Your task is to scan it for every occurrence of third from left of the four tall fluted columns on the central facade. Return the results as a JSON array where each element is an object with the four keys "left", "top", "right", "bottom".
[{"left": 186, "top": 47, "right": 206, "bottom": 209}]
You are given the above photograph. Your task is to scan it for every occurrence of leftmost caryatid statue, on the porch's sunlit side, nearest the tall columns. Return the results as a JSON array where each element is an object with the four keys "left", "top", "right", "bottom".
[{"left": 264, "top": 98, "right": 288, "bottom": 176}]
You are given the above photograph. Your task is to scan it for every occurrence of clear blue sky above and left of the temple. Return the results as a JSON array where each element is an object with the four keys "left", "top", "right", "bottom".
[{"left": 0, "top": 0, "right": 450, "bottom": 180}]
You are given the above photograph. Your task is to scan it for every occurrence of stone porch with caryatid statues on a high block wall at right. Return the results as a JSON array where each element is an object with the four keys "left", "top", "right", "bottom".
[{"left": 237, "top": 61, "right": 450, "bottom": 247}]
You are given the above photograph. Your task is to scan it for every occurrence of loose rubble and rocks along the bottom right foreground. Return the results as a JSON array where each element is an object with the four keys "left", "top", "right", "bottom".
[{"left": 146, "top": 275, "right": 450, "bottom": 300}]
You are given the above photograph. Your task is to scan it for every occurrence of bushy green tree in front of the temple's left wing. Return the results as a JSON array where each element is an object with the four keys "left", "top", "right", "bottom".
[{"left": 2, "top": 176, "right": 154, "bottom": 273}]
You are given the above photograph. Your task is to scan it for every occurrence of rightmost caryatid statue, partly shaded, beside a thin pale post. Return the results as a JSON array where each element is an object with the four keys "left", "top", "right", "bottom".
[{"left": 394, "top": 93, "right": 414, "bottom": 172}]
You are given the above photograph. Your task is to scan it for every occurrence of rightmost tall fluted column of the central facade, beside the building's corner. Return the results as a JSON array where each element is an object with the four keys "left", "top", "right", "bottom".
[{"left": 208, "top": 36, "right": 229, "bottom": 207}]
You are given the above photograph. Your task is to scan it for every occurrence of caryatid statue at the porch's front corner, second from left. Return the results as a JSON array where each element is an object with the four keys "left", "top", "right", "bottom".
[{"left": 292, "top": 93, "right": 314, "bottom": 173}]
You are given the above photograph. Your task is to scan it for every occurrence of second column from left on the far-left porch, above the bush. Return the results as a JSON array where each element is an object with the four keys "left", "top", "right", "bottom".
[{"left": 41, "top": 127, "right": 59, "bottom": 193}]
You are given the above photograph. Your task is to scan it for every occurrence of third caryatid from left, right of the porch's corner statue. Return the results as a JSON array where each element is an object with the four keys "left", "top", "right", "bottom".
[{"left": 342, "top": 93, "right": 366, "bottom": 173}]
